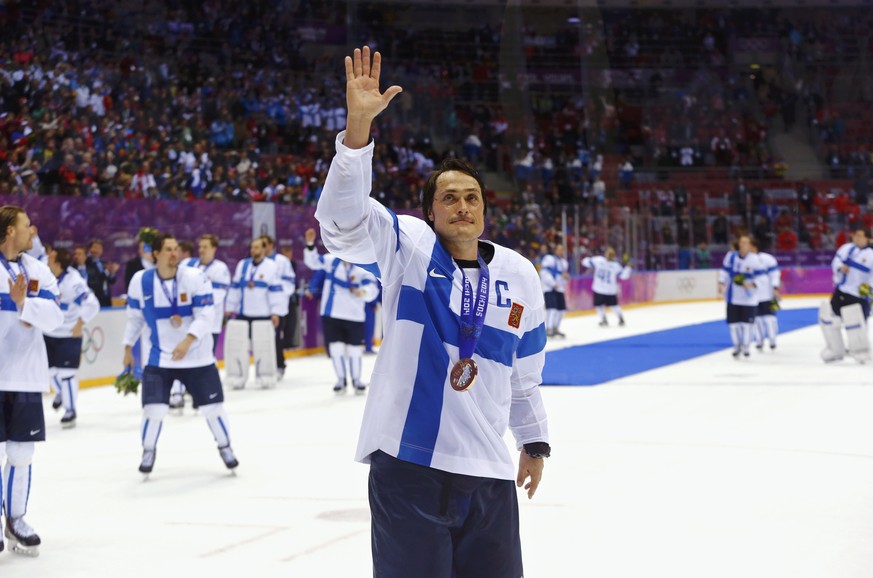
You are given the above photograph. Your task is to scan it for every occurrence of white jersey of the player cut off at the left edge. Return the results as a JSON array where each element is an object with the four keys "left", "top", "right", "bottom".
[{"left": 0, "top": 253, "right": 64, "bottom": 392}]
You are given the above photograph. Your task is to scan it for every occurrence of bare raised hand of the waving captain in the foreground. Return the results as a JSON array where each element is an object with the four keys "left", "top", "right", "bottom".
[{"left": 344, "top": 46, "right": 403, "bottom": 148}]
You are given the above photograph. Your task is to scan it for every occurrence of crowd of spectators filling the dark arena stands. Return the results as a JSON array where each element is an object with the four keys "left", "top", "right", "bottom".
[{"left": 0, "top": 0, "right": 871, "bottom": 264}]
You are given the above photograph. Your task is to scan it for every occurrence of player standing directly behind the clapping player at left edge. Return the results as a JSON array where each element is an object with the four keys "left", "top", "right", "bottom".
[{"left": 45, "top": 248, "right": 100, "bottom": 428}]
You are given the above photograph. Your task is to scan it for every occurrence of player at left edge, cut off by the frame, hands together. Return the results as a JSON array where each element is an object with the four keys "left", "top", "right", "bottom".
[{"left": 0, "top": 205, "right": 64, "bottom": 555}]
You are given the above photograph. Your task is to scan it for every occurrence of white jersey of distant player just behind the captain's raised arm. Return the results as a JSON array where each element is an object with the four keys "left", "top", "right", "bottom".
[{"left": 303, "top": 247, "right": 379, "bottom": 321}]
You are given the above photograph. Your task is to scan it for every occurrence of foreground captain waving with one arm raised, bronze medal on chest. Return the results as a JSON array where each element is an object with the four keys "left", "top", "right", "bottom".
[{"left": 315, "top": 47, "right": 549, "bottom": 578}]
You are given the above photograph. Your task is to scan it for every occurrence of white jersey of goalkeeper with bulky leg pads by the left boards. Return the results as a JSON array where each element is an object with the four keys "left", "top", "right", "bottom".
[{"left": 226, "top": 257, "right": 288, "bottom": 317}]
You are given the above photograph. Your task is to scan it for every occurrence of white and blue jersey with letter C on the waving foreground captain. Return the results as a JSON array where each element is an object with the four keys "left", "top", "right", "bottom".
[{"left": 315, "top": 133, "right": 548, "bottom": 480}]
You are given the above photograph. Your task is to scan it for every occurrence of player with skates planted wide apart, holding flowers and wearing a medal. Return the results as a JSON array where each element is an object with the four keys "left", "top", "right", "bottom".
[{"left": 123, "top": 233, "right": 239, "bottom": 475}]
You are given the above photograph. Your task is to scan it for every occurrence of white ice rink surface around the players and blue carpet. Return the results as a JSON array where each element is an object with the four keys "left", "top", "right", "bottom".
[{"left": 0, "top": 299, "right": 873, "bottom": 578}]
